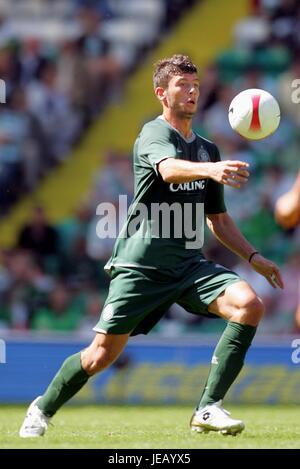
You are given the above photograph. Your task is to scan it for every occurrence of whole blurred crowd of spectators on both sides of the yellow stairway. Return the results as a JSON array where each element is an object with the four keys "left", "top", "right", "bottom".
[{"left": 0, "top": 0, "right": 300, "bottom": 334}]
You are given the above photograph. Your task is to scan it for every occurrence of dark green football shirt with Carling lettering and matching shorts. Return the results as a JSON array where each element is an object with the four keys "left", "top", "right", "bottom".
[{"left": 94, "top": 116, "right": 240, "bottom": 335}]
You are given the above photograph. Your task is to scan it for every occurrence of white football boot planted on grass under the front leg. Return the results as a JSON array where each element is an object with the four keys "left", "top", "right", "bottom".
[{"left": 190, "top": 400, "right": 245, "bottom": 436}]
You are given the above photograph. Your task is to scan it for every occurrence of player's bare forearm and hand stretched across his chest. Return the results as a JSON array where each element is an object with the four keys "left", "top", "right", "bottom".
[{"left": 158, "top": 157, "right": 249, "bottom": 188}]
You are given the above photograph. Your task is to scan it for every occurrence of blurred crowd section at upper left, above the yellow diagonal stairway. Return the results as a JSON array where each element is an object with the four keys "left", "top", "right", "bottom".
[{"left": 0, "top": 0, "right": 192, "bottom": 212}]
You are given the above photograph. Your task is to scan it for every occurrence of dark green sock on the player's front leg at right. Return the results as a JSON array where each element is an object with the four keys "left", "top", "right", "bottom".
[{"left": 197, "top": 322, "right": 256, "bottom": 409}]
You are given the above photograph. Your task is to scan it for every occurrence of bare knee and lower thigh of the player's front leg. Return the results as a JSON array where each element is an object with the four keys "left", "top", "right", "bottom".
[{"left": 208, "top": 280, "right": 264, "bottom": 326}]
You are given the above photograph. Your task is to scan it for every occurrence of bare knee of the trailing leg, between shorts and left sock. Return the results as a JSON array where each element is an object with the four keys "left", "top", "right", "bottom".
[{"left": 81, "top": 332, "right": 130, "bottom": 375}]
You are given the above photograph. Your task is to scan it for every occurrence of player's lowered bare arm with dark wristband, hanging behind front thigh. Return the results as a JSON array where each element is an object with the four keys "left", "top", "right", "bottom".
[{"left": 206, "top": 212, "right": 284, "bottom": 288}]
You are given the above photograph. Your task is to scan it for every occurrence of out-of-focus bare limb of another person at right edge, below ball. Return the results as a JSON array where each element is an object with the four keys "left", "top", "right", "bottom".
[{"left": 275, "top": 190, "right": 300, "bottom": 229}]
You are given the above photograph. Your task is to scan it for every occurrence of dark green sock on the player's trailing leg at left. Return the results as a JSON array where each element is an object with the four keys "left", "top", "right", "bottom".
[{"left": 37, "top": 352, "right": 89, "bottom": 417}]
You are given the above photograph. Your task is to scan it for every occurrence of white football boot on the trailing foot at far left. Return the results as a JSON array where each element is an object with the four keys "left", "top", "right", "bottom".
[{"left": 19, "top": 396, "right": 50, "bottom": 438}]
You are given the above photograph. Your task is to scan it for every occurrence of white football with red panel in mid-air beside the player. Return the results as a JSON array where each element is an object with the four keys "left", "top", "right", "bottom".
[{"left": 228, "top": 88, "right": 280, "bottom": 140}]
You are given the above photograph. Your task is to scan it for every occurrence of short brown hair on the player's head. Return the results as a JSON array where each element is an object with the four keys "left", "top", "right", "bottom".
[{"left": 153, "top": 54, "right": 198, "bottom": 88}]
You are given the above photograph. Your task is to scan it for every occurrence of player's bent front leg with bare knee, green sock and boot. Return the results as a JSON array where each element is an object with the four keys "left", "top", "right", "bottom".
[{"left": 191, "top": 281, "right": 264, "bottom": 434}]
